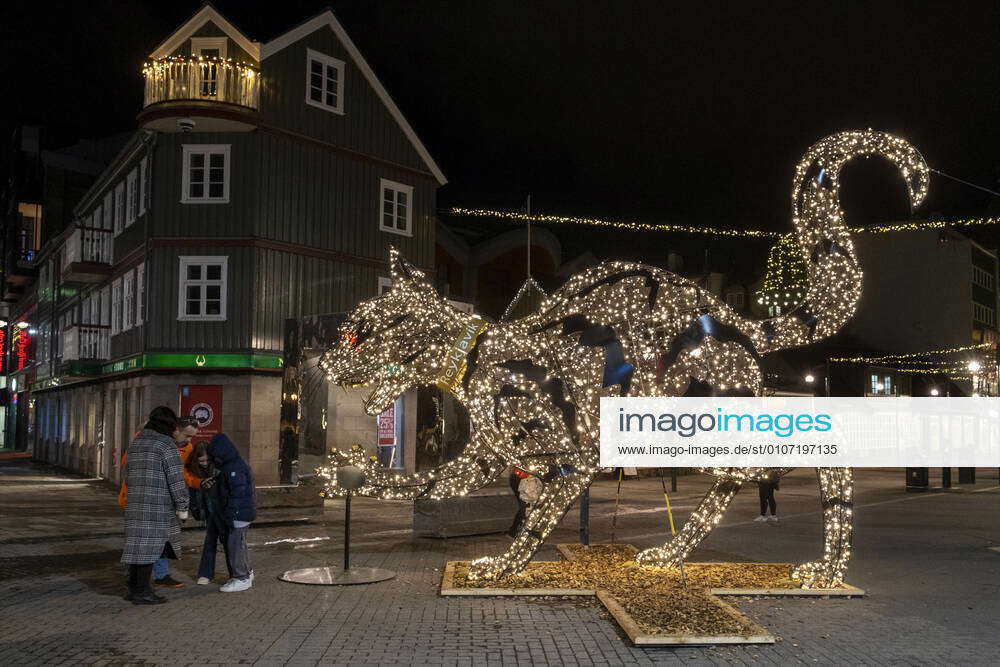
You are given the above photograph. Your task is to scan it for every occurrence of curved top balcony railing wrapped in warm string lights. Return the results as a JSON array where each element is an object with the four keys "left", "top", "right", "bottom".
[{"left": 142, "top": 56, "right": 260, "bottom": 109}]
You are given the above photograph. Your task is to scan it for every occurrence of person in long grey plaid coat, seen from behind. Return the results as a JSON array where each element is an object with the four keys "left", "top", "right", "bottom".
[{"left": 121, "top": 406, "right": 189, "bottom": 604}]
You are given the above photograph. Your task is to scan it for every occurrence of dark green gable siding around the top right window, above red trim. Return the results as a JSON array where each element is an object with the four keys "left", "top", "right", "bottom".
[{"left": 260, "top": 27, "right": 428, "bottom": 171}]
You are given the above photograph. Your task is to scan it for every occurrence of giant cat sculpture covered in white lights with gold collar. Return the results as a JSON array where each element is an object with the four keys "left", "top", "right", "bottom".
[{"left": 321, "top": 130, "right": 929, "bottom": 588}]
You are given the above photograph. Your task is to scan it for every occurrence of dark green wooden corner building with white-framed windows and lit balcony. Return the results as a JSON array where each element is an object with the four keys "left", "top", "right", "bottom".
[{"left": 1, "top": 6, "right": 445, "bottom": 484}]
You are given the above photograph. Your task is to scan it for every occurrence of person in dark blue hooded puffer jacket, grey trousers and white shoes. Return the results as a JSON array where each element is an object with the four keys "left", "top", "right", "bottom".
[{"left": 208, "top": 433, "right": 257, "bottom": 593}]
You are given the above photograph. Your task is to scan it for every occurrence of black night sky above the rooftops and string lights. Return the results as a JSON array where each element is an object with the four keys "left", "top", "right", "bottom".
[{"left": 0, "top": 0, "right": 1000, "bottom": 250}]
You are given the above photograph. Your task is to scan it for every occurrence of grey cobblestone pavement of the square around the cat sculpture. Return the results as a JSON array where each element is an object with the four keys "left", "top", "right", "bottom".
[{"left": 0, "top": 462, "right": 1000, "bottom": 666}]
